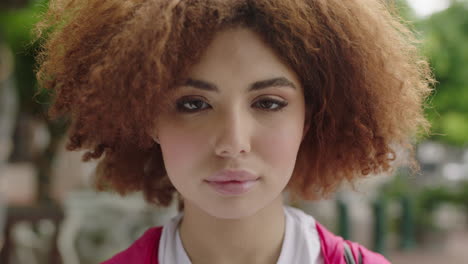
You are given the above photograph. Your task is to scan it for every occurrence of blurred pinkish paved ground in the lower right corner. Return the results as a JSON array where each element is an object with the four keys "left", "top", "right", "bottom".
[{"left": 388, "top": 230, "right": 468, "bottom": 264}]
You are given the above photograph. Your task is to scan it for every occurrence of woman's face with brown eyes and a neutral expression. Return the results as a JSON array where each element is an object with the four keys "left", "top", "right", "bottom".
[{"left": 152, "top": 28, "right": 305, "bottom": 219}]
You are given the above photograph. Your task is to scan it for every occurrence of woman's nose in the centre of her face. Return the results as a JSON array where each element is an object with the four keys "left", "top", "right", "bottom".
[{"left": 215, "top": 108, "right": 251, "bottom": 158}]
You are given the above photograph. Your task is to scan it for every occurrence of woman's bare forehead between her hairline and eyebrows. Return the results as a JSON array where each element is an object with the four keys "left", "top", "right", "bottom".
[{"left": 183, "top": 27, "right": 300, "bottom": 90}]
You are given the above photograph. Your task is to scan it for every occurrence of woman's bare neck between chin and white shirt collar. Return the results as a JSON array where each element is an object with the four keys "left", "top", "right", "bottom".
[{"left": 180, "top": 196, "right": 285, "bottom": 264}]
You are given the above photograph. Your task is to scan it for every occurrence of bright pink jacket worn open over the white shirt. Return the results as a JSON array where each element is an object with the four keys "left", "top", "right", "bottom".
[{"left": 101, "top": 222, "right": 390, "bottom": 264}]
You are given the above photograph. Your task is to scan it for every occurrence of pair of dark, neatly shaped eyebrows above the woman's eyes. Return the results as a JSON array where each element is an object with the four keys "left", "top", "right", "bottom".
[{"left": 179, "top": 77, "right": 296, "bottom": 92}]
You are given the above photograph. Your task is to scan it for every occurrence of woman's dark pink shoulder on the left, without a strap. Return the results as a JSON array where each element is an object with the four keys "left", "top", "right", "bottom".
[{"left": 101, "top": 226, "right": 162, "bottom": 264}]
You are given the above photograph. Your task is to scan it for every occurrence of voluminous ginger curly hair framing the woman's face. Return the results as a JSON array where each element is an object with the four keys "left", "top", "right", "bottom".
[{"left": 36, "top": 0, "right": 434, "bottom": 206}]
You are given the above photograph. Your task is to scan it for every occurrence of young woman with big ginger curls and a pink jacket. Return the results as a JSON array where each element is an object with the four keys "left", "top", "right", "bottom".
[{"left": 34, "top": 0, "right": 432, "bottom": 264}]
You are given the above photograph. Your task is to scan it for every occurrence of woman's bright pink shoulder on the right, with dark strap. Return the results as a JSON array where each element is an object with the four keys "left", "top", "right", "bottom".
[{"left": 316, "top": 222, "right": 390, "bottom": 264}]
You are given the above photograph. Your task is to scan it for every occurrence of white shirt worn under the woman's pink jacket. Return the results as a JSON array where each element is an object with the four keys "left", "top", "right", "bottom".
[{"left": 158, "top": 206, "right": 323, "bottom": 264}]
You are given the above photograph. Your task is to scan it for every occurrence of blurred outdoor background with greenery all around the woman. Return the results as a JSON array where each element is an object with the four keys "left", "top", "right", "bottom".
[{"left": 0, "top": 0, "right": 468, "bottom": 264}]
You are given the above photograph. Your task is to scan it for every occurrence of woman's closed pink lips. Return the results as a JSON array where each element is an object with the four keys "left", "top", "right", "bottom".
[{"left": 205, "top": 170, "right": 259, "bottom": 196}]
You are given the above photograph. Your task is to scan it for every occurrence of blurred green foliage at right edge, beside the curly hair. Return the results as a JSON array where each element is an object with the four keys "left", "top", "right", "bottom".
[{"left": 418, "top": 2, "right": 468, "bottom": 145}]
